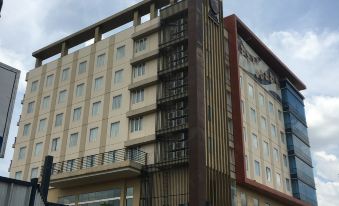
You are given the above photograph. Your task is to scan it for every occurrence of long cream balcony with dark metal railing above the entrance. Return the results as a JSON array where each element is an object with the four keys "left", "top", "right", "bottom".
[{"left": 50, "top": 149, "right": 147, "bottom": 188}]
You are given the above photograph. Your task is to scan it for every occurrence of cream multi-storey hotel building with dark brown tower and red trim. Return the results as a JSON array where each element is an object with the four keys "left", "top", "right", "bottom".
[{"left": 10, "top": 0, "right": 317, "bottom": 206}]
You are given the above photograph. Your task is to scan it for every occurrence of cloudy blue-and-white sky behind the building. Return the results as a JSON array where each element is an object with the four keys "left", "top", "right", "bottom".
[{"left": 0, "top": 0, "right": 339, "bottom": 206}]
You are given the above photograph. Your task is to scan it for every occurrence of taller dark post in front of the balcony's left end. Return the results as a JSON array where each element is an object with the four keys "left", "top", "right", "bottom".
[{"left": 41, "top": 156, "right": 53, "bottom": 202}]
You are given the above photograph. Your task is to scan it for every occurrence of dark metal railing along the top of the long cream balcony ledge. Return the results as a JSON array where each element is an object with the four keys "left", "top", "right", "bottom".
[{"left": 52, "top": 149, "right": 147, "bottom": 175}]
